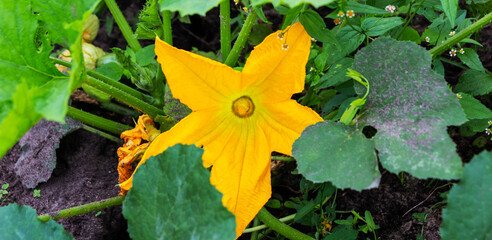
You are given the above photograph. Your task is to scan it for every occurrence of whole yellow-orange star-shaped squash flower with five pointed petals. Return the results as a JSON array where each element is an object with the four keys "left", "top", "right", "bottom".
[{"left": 122, "top": 23, "right": 323, "bottom": 236}]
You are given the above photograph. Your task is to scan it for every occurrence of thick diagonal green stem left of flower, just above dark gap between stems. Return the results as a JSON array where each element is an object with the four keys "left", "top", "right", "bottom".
[{"left": 85, "top": 77, "right": 165, "bottom": 118}]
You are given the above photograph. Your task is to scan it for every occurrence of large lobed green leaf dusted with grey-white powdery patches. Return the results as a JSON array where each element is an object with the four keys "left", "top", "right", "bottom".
[{"left": 353, "top": 38, "right": 467, "bottom": 179}]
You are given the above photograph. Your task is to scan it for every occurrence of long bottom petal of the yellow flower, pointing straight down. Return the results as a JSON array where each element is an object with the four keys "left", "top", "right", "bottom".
[{"left": 208, "top": 121, "right": 271, "bottom": 236}]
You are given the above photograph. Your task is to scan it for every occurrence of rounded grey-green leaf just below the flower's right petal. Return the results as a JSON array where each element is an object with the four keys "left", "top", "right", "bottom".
[{"left": 292, "top": 121, "right": 380, "bottom": 191}]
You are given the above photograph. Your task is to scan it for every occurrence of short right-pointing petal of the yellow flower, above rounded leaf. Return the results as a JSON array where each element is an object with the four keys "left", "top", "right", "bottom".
[{"left": 260, "top": 100, "right": 323, "bottom": 156}]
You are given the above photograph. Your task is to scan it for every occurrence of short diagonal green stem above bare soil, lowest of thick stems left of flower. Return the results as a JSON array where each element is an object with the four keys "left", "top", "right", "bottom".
[{"left": 67, "top": 107, "right": 132, "bottom": 135}]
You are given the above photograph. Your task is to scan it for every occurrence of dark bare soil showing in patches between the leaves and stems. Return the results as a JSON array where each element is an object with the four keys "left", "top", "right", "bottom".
[{"left": 0, "top": 0, "right": 492, "bottom": 240}]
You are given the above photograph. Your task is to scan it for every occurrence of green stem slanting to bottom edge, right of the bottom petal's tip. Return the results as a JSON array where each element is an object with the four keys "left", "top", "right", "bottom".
[{"left": 256, "top": 208, "right": 314, "bottom": 240}]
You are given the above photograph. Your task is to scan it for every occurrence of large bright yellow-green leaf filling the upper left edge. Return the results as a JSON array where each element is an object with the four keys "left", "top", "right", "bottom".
[{"left": 0, "top": 0, "right": 98, "bottom": 157}]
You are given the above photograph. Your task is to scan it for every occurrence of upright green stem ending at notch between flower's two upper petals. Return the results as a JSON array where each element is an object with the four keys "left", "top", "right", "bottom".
[{"left": 219, "top": 0, "right": 231, "bottom": 62}]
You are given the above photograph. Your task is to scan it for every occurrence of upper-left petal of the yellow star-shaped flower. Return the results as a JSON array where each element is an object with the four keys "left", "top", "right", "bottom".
[{"left": 155, "top": 38, "right": 241, "bottom": 110}]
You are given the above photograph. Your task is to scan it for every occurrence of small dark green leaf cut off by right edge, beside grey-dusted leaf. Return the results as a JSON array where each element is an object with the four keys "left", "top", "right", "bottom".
[{"left": 454, "top": 69, "right": 492, "bottom": 96}]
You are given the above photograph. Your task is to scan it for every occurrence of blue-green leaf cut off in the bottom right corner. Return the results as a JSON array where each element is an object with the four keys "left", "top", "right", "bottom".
[{"left": 439, "top": 152, "right": 492, "bottom": 240}]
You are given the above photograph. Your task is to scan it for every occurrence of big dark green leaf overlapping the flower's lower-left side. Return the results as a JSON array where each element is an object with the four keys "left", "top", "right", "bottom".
[{"left": 123, "top": 144, "right": 236, "bottom": 239}]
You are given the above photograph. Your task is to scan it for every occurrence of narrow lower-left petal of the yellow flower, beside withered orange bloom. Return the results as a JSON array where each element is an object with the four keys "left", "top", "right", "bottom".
[{"left": 120, "top": 111, "right": 217, "bottom": 190}]
